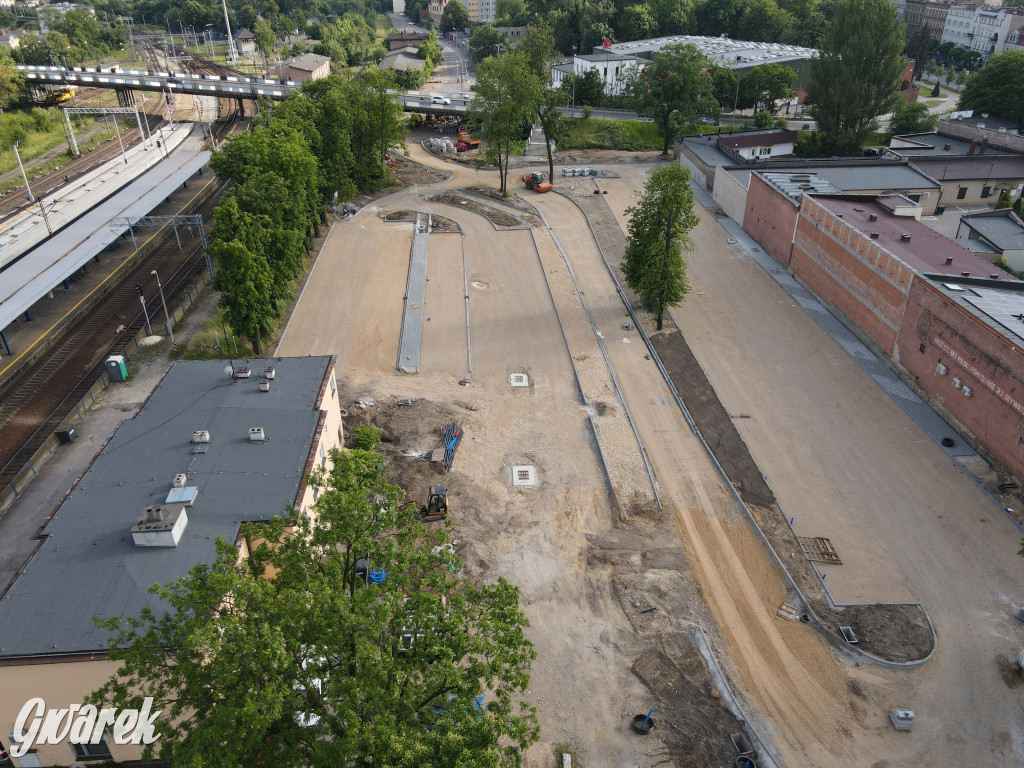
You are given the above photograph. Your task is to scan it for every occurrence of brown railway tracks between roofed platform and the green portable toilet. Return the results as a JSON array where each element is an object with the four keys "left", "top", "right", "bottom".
[{"left": 0, "top": 183, "right": 226, "bottom": 484}]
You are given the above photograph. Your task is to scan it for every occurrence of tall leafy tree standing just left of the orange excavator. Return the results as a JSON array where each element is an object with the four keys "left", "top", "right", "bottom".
[{"left": 470, "top": 50, "right": 543, "bottom": 195}]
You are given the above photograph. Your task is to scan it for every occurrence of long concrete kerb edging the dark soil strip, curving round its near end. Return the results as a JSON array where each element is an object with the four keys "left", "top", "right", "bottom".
[{"left": 558, "top": 182, "right": 938, "bottom": 670}]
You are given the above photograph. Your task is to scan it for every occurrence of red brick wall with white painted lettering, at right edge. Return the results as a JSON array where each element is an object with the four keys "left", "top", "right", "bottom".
[{"left": 897, "top": 278, "right": 1024, "bottom": 478}]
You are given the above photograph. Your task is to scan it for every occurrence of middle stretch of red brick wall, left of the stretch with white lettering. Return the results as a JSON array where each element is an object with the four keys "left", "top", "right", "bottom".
[{"left": 790, "top": 197, "right": 913, "bottom": 354}]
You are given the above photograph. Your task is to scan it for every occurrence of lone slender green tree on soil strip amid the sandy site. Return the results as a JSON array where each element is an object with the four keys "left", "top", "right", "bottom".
[{"left": 623, "top": 161, "right": 698, "bottom": 331}]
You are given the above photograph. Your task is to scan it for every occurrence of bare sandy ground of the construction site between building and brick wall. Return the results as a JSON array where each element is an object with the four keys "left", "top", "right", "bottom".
[{"left": 280, "top": 148, "right": 1024, "bottom": 767}]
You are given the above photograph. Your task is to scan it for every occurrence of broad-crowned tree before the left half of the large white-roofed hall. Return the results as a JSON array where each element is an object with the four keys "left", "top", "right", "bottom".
[{"left": 626, "top": 43, "right": 718, "bottom": 155}]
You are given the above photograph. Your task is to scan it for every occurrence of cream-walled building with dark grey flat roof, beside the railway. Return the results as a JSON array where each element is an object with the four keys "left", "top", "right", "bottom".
[{"left": 0, "top": 357, "right": 342, "bottom": 766}]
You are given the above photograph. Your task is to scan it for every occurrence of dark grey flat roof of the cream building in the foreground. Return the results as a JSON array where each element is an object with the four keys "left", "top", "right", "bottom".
[{"left": 0, "top": 357, "right": 331, "bottom": 657}]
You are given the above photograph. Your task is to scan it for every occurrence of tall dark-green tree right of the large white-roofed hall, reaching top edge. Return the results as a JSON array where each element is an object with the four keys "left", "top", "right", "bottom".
[{"left": 808, "top": 0, "right": 905, "bottom": 155}]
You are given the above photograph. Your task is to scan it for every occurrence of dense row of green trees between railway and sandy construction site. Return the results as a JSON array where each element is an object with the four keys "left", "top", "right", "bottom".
[{"left": 210, "top": 68, "right": 404, "bottom": 354}]
